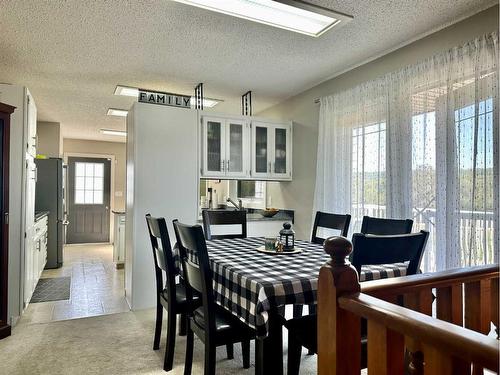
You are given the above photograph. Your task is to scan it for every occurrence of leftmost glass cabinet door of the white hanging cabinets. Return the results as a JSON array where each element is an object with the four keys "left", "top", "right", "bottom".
[{"left": 203, "top": 118, "right": 226, "bottom": 176}]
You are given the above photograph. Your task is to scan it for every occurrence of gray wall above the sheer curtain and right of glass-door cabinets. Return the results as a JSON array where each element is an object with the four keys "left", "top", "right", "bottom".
[{"left": 258, "top": 5, "right": 499, "bottom": 238}]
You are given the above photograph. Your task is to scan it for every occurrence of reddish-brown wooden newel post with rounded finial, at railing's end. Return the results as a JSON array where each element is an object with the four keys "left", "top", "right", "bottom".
[{"left": 318, "top": 237, "right": 361, "bottom": 375}]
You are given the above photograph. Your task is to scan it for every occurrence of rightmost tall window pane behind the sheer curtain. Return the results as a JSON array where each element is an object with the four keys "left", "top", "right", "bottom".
[{"left": 455, "top": 98, "right": 496, "bottom": 266}]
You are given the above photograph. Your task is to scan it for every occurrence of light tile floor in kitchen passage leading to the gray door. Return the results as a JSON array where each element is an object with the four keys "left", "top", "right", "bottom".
[{"left": 19, "top": 245, "right": 129, "bottom": 324}]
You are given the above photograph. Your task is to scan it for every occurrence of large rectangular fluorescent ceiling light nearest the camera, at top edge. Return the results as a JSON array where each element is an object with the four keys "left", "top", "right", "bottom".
[{"left": 174, "top": 0, "right": 352, "bottom": 37}]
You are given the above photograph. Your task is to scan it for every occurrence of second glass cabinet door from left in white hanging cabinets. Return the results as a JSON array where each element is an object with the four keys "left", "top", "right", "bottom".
[{"left": 226, "top": 120, "right": 248, "bottom": 176}]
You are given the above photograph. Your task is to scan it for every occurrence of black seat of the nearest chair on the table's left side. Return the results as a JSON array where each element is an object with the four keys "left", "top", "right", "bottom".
[{"left": 192, "top": 307, "right": 255, "bottom": 343}]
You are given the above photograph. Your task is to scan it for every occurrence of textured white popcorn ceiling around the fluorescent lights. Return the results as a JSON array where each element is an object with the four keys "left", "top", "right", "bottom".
[{"left": 0, "top": 0, "right": 495, "bottom": 141}]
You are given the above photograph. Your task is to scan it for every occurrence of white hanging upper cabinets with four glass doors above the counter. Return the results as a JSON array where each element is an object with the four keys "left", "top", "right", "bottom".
[{"left": 201, "top": 115, "right": 292, "bottom": 180}]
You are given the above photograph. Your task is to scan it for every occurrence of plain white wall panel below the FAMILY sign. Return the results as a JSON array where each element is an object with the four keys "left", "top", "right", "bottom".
[{"left": 125, "top": 103, "right": 199, "bottom": 310}]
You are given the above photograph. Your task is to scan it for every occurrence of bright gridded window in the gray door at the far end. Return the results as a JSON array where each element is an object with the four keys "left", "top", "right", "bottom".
[{"left": 75, "top": 162, "right": 104, "bottom": 204}]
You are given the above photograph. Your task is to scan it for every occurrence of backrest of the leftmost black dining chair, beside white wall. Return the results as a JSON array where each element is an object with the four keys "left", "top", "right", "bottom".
[{"left": 146, "top": 214, "right": 176, "bottom": 303}]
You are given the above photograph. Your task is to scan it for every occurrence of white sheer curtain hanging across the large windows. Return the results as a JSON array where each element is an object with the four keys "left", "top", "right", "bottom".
[{"left": 315, "top": 33, "right": 500, "bottom": 271}]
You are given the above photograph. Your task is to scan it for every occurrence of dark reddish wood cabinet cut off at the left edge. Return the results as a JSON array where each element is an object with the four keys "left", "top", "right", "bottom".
[{"left": 0, "top": 103, "right": 16, "bottom": 339}]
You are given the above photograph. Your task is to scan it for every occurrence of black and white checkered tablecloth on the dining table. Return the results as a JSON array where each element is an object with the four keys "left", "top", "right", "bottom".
[{"left": 174, "top": 237, "right": 407, "bottom": 336}]
